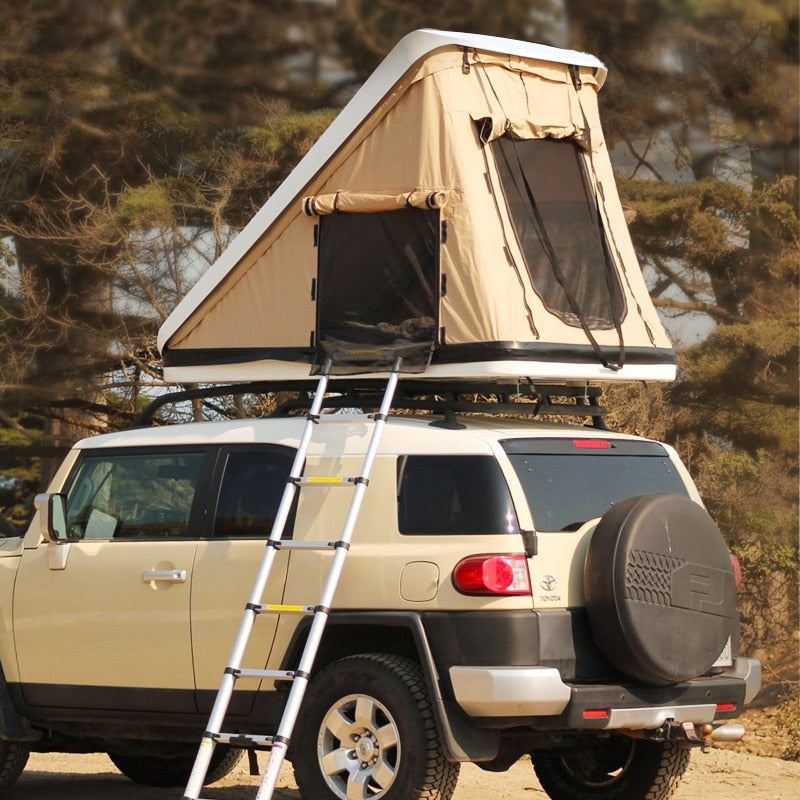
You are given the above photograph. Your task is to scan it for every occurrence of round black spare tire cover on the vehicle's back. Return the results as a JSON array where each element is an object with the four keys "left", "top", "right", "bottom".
[{"left": 584, "top": 494, "right": 737, "bottom": 686}]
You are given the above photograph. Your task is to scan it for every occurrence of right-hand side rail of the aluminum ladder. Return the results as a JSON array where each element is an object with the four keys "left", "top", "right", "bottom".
[{"left": 255, "top": 358, "right": 401, "bottom": 800}]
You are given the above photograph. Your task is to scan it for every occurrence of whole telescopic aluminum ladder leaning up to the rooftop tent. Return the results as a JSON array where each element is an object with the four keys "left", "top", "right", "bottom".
[{"left": 184, "top": 358, "right": 401, "bottom": 800}]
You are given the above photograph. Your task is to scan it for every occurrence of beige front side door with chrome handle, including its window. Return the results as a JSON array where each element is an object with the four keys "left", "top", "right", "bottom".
[{"left": 14, "top": 448, "right": 210, "bottom": 712}]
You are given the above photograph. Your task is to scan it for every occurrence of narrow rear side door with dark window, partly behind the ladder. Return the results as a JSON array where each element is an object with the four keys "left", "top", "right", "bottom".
[{"left": 191, "top": 445, "right": 296, "bottom": 714}]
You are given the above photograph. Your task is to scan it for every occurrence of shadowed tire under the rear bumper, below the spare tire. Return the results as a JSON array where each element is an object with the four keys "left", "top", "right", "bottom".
[{"left": 531, "top": 734, "right": 689, "bottom": 800}]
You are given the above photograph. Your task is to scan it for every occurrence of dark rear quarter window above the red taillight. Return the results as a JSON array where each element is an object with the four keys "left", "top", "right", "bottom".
[{"left": 397, "top": 456, "right": 519, "bottom": 534}]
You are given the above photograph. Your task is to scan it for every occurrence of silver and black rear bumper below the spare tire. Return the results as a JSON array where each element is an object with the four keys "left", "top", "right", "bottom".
[{"left": 449, "top": 658, "right": 761, "bottom": 730}]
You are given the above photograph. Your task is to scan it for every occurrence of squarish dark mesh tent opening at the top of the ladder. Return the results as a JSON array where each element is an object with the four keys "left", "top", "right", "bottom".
[{"left": 317, "top": 208, "right": 440, "bottom": 372}]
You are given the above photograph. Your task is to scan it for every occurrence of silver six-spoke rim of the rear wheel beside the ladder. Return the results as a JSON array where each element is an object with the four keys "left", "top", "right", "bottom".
[{"left": 317, "top": 694, "right": 400, "bottom": 800}]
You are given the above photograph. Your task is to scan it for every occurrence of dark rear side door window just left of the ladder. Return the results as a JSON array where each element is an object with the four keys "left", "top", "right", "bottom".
[{"left": 214, "top": 451, "right": 293, "bottom": 539}]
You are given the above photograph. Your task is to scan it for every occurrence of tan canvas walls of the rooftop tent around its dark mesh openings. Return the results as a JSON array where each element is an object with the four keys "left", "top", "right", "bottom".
[{"left": 161, "top": 36, "right": 674, "bottom": 381}]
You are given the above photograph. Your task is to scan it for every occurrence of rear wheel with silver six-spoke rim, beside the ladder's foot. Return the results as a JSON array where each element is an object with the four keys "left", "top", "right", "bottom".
[{"left": 289, "top": 654, "right": 460, "bottom": 800}]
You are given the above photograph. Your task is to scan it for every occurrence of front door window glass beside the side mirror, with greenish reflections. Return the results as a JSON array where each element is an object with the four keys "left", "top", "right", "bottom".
[{"left": 67, "top": 451, "right": 206, "bottom": 539}]
